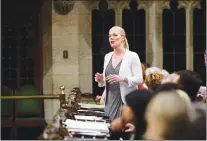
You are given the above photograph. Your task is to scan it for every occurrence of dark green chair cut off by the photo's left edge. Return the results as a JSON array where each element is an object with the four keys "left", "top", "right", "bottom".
[{"left": 1, "top": 86, "right": 14, "bottom": 140}]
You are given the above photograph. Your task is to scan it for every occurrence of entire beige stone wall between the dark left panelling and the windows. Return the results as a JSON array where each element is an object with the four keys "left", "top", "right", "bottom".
[{"left": 43, "top": 1, "right": 92, "bottom": 122}]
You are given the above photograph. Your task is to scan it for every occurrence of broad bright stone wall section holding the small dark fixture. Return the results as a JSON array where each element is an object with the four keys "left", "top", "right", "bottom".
[{"left": 50, "top": 1, "right": 82, "bottom": 118}]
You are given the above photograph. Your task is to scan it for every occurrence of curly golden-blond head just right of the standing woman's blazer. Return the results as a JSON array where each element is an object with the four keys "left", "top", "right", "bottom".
[{"left": 144, "top": 73, "right": 164, "bottom": 92}]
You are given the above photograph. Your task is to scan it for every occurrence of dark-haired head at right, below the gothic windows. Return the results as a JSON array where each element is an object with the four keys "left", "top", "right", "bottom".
[{"left": 175, "top": 70, "right": 202, "bottom": 101}]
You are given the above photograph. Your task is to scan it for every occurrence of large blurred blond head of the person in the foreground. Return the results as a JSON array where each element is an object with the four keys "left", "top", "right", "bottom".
[{"left": 145, "top": 92, "right": 191, "bottom": 139}]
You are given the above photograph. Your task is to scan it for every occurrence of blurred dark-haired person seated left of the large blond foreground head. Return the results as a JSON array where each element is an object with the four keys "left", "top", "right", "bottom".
[{"left": 111, "top": 90, "right": 153, "bottom": 140}]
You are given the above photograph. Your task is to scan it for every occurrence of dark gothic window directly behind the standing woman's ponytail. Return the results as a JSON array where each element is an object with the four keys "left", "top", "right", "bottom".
[{"left": 122, "top": 9, "right": 146, "bottom": 63}]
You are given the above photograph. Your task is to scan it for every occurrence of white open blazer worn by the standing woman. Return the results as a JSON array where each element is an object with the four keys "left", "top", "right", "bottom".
[{"left": 98, "top": 49, "right": 143, "bottom": 104}]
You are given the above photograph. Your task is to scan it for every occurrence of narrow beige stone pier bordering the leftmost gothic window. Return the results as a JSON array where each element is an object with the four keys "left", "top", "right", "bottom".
[{"left": 78, "top": 1, "right": 93, "bottom": 93}]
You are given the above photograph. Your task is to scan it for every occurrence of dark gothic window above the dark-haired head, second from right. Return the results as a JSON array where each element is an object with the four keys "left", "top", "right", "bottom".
[{"left": 162, "top": 8, "right": 186, "bottom": 73}]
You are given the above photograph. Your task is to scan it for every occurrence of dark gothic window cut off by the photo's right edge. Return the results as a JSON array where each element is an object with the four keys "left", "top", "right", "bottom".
[{"left": 193, "top": 2, "right": 206, "bottom": 85}]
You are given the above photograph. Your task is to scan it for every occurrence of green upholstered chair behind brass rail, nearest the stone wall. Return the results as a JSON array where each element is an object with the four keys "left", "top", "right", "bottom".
[{"left": 14, "top": 85, "right": 46, "bottom": 139}]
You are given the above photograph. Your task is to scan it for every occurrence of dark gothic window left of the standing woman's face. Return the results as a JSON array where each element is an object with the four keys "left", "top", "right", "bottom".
[{"left": 92, "top": 9, "right": 115, "bottom": 95}]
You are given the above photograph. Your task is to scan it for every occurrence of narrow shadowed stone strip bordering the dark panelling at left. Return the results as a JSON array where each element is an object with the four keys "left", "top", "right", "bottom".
[{"left": 41, "top": 1, "right": 53, "bottom": 123}]
